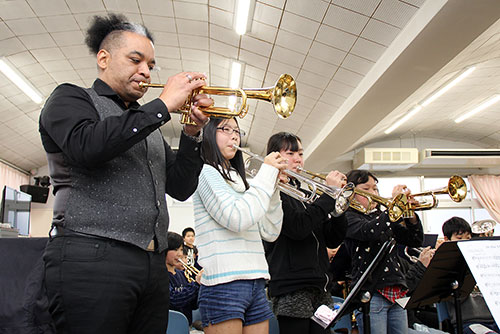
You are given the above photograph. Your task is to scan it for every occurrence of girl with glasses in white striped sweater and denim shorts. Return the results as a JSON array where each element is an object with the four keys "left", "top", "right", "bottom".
[{"left": 193, "top": 118, "right": 288, "bottom": 334}]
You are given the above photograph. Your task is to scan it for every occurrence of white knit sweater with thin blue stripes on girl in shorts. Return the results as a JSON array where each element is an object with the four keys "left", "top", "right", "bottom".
[{"left": 193, "top": 164, "right": 283, "bottom": 285}]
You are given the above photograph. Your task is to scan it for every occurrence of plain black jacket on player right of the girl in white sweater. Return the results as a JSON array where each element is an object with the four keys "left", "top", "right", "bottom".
[{"left": 264, "top": 183, "right": 347, "bottom": 297}]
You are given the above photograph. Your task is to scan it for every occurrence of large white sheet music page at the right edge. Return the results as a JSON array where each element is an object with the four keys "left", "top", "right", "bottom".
[{"left": 457, "top": 240, "right": 500, "bottom": 324}]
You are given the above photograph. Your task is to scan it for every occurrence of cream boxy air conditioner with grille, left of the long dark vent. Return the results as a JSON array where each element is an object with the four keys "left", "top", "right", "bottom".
[{"left": 352, "top": 148, "right": 419, "bottom": 171}]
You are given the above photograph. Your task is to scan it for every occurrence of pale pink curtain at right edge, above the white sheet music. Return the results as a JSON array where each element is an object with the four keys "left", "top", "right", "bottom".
[{"left": 468, "top": 175, "right": 500, "bottom": 223}]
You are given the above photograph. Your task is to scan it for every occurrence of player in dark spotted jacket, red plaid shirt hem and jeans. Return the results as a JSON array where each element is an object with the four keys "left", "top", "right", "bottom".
[{"left": 344, "top": 169, "right": 424, "bottom": 334}]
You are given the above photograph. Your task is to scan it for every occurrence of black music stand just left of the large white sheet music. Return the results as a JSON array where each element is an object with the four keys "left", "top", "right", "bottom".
[{"left": 397, "top": 241, "right": 476, "bottom": 334}]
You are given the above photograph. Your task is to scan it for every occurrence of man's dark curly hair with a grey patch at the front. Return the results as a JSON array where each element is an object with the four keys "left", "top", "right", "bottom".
[{"left": 85, "top": 14, "right": 154, "bottom": 54}]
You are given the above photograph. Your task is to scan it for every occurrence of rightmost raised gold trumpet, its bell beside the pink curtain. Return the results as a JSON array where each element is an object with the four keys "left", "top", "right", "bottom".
[{"left": 404, "top": 175, "right": 467, "bottom": 217}]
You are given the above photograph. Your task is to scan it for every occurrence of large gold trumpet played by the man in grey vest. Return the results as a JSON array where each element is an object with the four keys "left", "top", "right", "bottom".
[{"left": 139, "top": 74, "right": 297, "bottom": 124}]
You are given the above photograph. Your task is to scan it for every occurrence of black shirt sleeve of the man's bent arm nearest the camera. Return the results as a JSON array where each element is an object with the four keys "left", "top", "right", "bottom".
[{"left": 40, "top": 84, "right": 170, "bottom": 168}]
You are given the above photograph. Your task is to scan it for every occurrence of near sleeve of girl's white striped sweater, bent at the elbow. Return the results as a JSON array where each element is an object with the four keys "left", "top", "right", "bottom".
[{"left": 198, "top": 164, "right": 283, "bottom": 232}]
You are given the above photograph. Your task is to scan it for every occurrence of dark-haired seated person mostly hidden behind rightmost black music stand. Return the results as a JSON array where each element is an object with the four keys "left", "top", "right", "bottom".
[{"left": 443, "top": 217, "right": 500, "bottom": 334}]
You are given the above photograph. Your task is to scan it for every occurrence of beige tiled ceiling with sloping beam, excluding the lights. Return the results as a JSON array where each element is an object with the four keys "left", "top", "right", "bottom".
[{"left": 0, "top": 0, "right": 500, "bottom": 177}]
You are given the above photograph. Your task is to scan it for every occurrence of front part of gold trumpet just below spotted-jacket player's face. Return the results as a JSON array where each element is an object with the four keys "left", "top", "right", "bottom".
[{"left": 350, "top": 188, "right": 408, "bottom": 222}]
